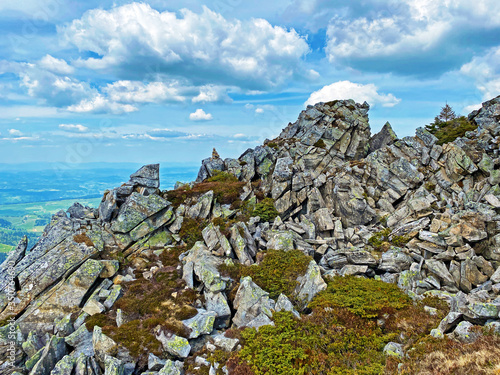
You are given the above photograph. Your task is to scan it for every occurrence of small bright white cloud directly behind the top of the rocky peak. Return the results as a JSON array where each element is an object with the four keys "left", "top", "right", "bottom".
[{"left": 306, "top": 81, "right": 401, "bottom": 107}]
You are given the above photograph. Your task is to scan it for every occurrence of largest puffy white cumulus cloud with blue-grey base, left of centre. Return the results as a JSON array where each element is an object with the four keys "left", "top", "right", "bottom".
[{"left": 59, "top": 3, "right": 309, "bottom": 89}]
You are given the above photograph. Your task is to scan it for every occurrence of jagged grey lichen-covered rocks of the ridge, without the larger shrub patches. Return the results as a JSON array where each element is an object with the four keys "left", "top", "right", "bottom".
[{"left": 0, "top": 97, "right": 500, "bottom": 375}]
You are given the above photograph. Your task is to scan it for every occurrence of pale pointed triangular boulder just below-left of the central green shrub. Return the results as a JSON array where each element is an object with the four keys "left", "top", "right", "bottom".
[{"left": 233, "top": 276, "right": 275, "bottom": 327}]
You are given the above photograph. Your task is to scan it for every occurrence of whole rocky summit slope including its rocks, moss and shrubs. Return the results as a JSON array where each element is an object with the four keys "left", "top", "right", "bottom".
[{"left": 0, "top": 97, "right": 500, "bottom": 375}]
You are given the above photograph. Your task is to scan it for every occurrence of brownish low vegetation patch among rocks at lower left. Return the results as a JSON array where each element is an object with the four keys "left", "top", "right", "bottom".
[{"left": 85, "top": 248, "right": 202, "bottom": 361}]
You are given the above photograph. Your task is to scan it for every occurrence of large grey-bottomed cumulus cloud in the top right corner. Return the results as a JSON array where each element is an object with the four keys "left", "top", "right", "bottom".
[{"left": 325, "top": 0, "right": 500, "bottom": 74}]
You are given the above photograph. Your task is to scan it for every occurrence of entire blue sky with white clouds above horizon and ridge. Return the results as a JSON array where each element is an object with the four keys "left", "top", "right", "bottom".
[{"left": 0, "top": 0, "right": 500, "bottom": 163}]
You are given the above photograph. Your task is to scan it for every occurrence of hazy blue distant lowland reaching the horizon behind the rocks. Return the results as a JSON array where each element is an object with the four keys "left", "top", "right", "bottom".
[{"left": 0, "top": 163, "right": 199, "bottom": 261}]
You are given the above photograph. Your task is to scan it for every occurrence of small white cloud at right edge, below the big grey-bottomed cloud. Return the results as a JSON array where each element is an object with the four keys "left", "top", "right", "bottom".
[{"left": 460, "top": 47, "right": 500, "bottom": 100}]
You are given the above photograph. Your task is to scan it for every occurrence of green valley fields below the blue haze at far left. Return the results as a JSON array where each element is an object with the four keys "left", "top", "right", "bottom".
[{"left": 0, "top": 198, "right": 101, "bottom": 253}]
